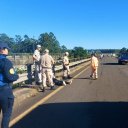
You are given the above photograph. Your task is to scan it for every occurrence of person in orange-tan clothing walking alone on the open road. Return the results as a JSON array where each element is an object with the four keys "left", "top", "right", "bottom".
[{"left": 90, "top": 53, "right": 99, "bottom": 79}]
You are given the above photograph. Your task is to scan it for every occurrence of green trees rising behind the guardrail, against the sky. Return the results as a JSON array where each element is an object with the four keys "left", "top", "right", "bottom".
[{"left": 0, "top": 32, "right": 87, "bottom": 58}]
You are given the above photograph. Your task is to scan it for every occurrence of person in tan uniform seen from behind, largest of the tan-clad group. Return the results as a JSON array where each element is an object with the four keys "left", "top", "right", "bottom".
[{"left": 41, "top": 49, "right": 54, "bottom": 91}]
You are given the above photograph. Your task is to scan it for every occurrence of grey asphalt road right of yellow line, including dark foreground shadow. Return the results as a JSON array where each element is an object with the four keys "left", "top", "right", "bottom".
[{"left": 11, "top": 57, "right": 128, "bottom": 128}]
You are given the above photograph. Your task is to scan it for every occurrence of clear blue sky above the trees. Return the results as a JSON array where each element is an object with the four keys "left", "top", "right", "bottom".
[{"left": 0, "top": 0, "right": 128, "bottom": 49}]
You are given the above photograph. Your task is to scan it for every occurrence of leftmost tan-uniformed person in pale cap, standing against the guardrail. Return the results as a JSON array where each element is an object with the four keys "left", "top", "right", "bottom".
[{"left": 33, "top": 45, "right": 42, "bottom": 85}]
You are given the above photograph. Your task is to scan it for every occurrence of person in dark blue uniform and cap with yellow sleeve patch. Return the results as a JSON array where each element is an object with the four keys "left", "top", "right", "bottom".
[{"left": 0, "top": 43, "right": 19, "bottom": 128}]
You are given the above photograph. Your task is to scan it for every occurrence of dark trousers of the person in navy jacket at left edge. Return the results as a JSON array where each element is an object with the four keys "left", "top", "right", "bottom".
[{"left": 0, "top": 84, "right": 14, "bottom": 128}]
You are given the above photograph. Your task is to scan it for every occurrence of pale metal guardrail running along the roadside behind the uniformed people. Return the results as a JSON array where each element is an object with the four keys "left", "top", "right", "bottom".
[{"left": 13, "top": 58, "right": 90, "bottom": 84}]
